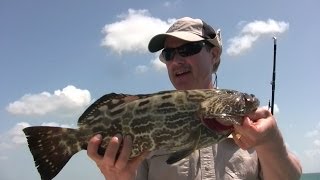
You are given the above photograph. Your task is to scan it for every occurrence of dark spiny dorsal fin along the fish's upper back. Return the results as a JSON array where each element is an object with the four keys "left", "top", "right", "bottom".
[{"left": 78, "top": 93, "right": 143, "bottom": 126}]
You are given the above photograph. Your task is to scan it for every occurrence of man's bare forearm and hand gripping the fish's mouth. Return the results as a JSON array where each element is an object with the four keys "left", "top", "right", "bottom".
[{"left": 234, "top": 108, "right": 302, "bottom": 180}]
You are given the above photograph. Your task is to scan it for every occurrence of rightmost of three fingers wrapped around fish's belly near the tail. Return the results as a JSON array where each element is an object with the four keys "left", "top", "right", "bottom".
[{"left": 115, "top": 135, "right": 132, "bottom": 169}]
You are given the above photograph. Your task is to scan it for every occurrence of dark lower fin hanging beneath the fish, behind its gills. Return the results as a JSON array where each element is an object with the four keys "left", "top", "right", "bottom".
[{"left": 166, "top": 128, "right": 201, "bottom": 164}]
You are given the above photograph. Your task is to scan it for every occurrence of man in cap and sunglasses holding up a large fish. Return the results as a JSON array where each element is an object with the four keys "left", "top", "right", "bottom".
[{"left": 87, "top": 17, "right": 302, "bottom": 180}]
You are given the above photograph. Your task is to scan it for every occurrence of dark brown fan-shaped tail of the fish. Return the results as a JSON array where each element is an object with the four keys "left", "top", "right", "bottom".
[{"left": 23, "top": 126, "right": 81, "bottom": 180}]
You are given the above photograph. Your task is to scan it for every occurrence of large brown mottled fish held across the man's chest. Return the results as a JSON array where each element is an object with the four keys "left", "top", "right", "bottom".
[{"left": 23, "top": 89, "right": 259, "bottom": 180}]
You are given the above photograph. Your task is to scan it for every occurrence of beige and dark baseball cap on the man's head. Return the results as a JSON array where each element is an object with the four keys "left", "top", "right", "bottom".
[{"left": 148, "top": 17, "right": 222, "bottom": 70}]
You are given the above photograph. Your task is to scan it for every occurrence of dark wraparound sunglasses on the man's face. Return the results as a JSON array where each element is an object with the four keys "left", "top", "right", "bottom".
[{"left": 160, "top": 41, "right": 206, "bottom": 62}]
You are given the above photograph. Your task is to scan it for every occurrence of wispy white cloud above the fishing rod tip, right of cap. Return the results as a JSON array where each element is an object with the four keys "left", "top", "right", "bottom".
[{"left": 226, "top": 19, "right": 289, "bottom": 56}]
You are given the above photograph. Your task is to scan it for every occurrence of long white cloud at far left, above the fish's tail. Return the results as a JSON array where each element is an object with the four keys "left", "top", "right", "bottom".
[{"left": 6, "top": 85, "right": 91, "bottom": 115}]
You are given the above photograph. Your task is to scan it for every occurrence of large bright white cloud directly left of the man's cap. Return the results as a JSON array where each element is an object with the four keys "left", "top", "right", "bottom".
[{"left": 101, "top": 9, "right": 173, "bottom": 54}]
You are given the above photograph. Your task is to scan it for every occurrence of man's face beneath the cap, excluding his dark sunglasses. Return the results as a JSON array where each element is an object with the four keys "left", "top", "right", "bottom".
[{"left": 164, "top": 37, "right": 218, "bottom": 90}]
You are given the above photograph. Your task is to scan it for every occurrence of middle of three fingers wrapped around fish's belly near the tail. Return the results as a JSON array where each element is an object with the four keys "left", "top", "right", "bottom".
[{"left": 103, "top": 134, "right": 122, "bottom": 166}]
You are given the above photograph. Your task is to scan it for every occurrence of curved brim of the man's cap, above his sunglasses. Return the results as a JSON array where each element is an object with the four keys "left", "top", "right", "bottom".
[{"left": 148, "top": 31, "right": 204, "bottom": 52}]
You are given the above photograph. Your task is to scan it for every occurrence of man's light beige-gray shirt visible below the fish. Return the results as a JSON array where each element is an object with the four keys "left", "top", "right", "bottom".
[{"left": 136, "top": 137, "right": 261, "bottom": 180}]
